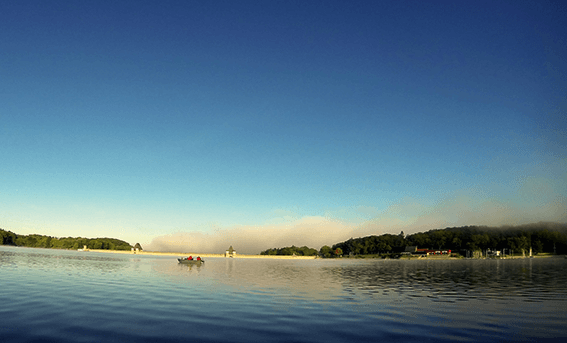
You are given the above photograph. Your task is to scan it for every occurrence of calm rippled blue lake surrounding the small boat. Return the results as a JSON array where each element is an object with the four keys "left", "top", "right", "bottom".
[{"left": 0, "top": 246, "right": 567, "bottom": 343}]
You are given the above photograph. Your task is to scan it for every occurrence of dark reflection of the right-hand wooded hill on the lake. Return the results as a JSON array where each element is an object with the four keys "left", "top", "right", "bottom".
[{"left": 331, "top": 258, "right": 567, "bottom": 301}]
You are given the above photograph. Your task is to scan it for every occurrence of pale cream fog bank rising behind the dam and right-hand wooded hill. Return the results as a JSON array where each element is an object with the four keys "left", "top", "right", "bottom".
[{"left": 145, "top": 179, "right": 567, "bottom": 254}]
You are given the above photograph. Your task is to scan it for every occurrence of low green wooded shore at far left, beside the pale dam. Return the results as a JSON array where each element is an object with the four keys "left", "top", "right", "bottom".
[{"left": 0, "top": 229, "right": 132, "bottom": 250}]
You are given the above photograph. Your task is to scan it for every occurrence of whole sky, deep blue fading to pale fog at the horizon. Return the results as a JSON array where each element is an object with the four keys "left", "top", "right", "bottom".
[{"left": 0, "top": 1, "right": 567, "bottom": 253}]
